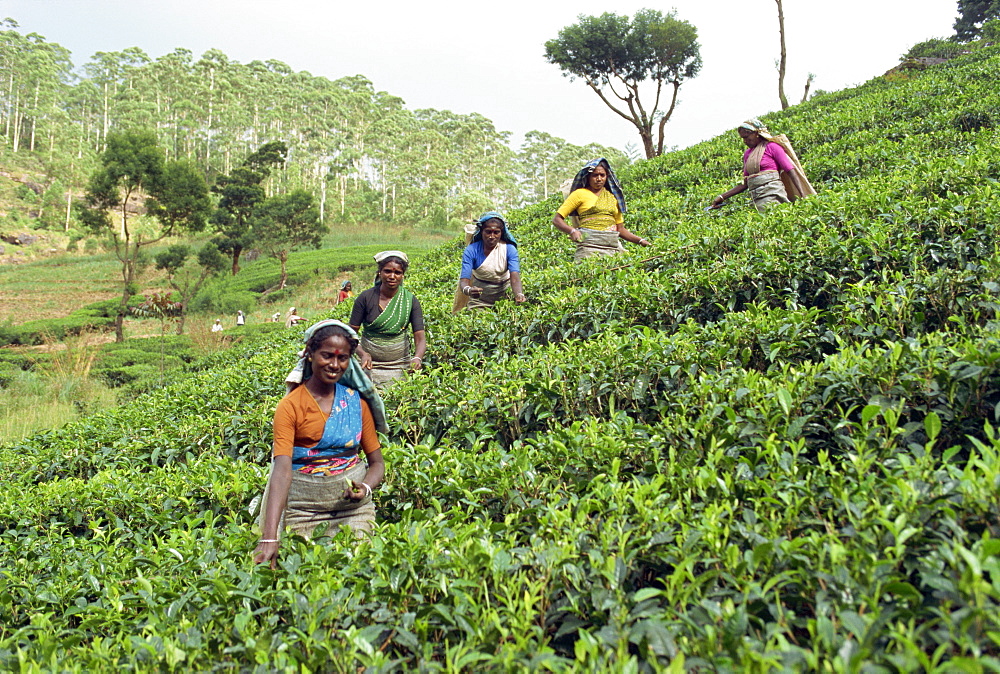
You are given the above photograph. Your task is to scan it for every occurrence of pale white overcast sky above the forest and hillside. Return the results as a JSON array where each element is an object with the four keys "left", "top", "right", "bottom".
[{"left": 0, "top": 0, "right": 957, "bottom": 149}]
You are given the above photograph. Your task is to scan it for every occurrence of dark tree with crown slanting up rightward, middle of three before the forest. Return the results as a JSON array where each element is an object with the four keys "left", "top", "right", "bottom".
[{"left": 212, "top": 141, "right": 288, "bottom": 276}]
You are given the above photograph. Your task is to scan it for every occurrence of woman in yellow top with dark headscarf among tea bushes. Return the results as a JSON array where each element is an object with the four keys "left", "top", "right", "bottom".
[{"left": 552, "top": 157, "right": 650, "bottom": 262}]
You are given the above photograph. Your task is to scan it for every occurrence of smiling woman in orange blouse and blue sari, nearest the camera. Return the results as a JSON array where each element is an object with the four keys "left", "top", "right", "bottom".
[{"left": 253, "top": 320, "right": 388, "bottom": 567}]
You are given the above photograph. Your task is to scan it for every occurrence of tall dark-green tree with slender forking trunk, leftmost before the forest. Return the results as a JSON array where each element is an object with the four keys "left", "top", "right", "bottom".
[{"left": 79, "top": 130, "right": 211, "bottom": 342}]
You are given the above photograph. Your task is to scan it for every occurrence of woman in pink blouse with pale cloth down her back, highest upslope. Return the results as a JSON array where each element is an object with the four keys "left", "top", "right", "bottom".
[{"left": 712, "top": 119, "right": 816, "bottom": 213}]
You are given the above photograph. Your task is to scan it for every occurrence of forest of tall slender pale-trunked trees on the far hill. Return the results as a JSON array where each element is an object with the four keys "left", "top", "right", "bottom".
[{"left": 0, "top": 19, "right": 626, "bottom": 226}]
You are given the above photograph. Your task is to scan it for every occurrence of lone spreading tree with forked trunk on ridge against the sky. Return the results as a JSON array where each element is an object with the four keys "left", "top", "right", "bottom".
[{"left": 545, "top": 9, "right": 701, "bottom": 158}]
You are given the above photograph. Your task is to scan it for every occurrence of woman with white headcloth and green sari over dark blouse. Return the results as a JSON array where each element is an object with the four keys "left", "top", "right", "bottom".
[{"left": 350, "top": 250, "right": 427, "bottom": 386}]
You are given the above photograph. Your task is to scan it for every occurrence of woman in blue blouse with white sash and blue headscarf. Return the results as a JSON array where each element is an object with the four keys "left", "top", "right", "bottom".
[{"left": 453, "top": 211, "right": 526, "bottom": 312}]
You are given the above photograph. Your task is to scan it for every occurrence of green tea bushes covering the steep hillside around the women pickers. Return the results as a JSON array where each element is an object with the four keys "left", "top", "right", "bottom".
[{"left": 0, "top": 49, "right": 1000, "bottom": 672}]
